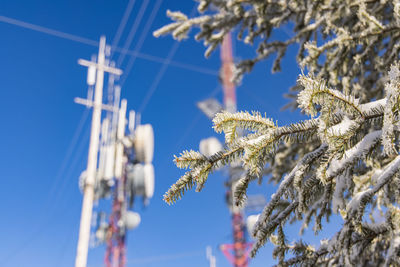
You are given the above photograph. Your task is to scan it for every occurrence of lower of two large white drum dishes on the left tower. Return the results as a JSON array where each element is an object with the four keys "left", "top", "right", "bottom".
[{"left": 127, "top": 164, "right": 154, "bottom": 199}]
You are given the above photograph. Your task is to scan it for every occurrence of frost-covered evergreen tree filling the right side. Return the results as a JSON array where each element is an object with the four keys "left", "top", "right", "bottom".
[{"left": 154, "top": 0, "right": 400, "bottom": 266}]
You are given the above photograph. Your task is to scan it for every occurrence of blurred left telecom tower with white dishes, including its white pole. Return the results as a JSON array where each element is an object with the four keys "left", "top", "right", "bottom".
[{"left": 75, "top": 37, "right": 154, "bottom": 267}]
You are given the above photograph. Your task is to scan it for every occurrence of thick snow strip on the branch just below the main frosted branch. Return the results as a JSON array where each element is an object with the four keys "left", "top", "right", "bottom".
[{"left": 326, "top": 131, "right": 382, "bottom": 177}]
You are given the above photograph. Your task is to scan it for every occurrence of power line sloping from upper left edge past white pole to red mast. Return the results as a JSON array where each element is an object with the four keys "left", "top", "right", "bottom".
[{"left": 0, "top": 15, "right": 218, "bottom": 76}]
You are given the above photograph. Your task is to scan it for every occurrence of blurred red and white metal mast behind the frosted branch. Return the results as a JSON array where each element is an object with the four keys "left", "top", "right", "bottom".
[{"left": 217, "top": 33, "right": 250, "bottom": 267}]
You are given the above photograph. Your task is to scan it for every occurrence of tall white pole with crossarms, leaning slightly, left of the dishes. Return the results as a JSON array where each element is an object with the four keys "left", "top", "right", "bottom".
[{"left": 75, "top": 36, "right": 106, "bottom": 267}]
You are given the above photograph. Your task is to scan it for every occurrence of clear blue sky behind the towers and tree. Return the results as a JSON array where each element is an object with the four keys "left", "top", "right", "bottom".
[{"left": 0, "top": 0, "right": 338, "bottom": 267}]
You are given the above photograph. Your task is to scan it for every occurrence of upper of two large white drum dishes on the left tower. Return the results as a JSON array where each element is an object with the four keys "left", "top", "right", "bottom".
[{"left": 134, "top": 124, "right": 154, "bottom": 163}]
